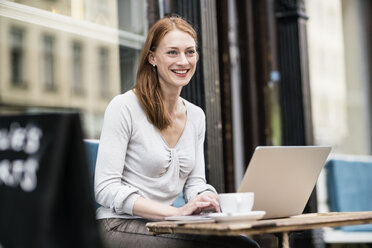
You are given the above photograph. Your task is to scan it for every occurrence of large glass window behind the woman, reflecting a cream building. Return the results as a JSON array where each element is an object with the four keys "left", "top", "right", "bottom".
[{"left": 0, "top": 0, "right": 147, "bottom": 138}]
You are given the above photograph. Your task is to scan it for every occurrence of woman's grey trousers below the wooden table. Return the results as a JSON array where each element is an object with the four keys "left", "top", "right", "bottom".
[{"left": 98, "top": 218, "right": 260, "bottom": 248}]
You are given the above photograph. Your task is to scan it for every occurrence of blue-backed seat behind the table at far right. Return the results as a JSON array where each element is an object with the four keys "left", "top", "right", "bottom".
[{"left": 319, "top": 156, "right": 372, "bottom": 243}]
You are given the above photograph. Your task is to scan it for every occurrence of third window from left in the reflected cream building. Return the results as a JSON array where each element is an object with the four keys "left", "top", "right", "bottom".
[{"left": 71, "top": 42, "right": 83, "bottom": 95}]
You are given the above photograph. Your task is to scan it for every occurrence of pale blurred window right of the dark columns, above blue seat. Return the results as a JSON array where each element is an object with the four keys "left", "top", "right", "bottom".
[{"left": 307, "top": 0, "right": 372, "bottom": 155}]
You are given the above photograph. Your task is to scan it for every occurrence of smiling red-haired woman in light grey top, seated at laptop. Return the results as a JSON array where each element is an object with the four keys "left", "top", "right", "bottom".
[{"left": 95, "top": 17, "right": 258, "bottom": 247}]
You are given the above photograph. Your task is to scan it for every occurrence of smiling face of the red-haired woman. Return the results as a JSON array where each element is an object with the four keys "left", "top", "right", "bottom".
[{"left": 148, "top": 29, "right": 198, "bottom": 88}]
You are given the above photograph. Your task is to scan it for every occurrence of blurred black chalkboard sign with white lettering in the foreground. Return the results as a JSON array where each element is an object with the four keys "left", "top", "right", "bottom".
[{"left": 0, "top": 114, "right": 101, "bottom": 248}]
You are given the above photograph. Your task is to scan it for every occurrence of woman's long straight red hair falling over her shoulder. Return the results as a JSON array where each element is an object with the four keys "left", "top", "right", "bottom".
[{"left": 133, "top": 16, "right": 197, "bottom": 130}]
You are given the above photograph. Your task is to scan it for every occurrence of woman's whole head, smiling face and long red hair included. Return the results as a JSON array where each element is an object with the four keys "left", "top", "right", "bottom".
[{"left": 134, "top": 17, "right": 198, "bottom": 130}]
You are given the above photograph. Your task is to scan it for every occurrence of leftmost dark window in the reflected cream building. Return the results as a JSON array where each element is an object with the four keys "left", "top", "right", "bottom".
[{"left": 10, "top": 27, "right": 25, "bottom": 86}]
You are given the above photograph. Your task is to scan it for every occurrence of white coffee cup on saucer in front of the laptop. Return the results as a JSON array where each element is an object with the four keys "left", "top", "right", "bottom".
[{"left": 218, "top": 192, "right": 254, "bottom": 214}]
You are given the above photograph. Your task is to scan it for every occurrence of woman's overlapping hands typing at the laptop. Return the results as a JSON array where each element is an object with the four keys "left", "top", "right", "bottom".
[{"left": 178, "top": 191, "right": 221, "bottom": 215}]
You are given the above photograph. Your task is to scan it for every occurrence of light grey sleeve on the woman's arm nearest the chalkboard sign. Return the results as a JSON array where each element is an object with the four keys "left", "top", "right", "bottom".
[{"left": 94, "top": 96, "right": 140, "bottom": 215}]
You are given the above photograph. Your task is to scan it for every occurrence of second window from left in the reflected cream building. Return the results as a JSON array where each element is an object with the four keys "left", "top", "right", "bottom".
[{"left": 43, "top": 35, "right": 56, "bottom": 90}]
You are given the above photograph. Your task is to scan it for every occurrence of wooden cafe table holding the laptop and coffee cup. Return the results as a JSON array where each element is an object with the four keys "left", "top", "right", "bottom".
[{"left": 146, "top": 211, "right": 372, "bottom": 248}]
